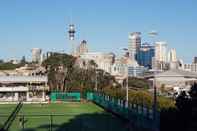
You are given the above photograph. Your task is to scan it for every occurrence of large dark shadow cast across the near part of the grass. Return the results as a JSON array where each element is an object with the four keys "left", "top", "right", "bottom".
[{"left": 21, "top": 112, "right": 131, "bottom": 131}]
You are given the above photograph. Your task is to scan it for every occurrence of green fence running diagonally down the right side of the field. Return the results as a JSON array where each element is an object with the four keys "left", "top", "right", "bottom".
[{"left": 92, "top": 93, "right": 160, "bottom": 130}]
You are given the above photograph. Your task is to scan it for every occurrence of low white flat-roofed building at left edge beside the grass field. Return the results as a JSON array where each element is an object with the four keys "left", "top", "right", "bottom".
[{"left": 0, "top": 76, "right": 49, "bottom": 102}]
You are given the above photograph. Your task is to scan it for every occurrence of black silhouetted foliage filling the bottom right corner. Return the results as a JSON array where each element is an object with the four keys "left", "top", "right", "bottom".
[{"left": 161, "top": 84, "right": 197, "bottom": 131}]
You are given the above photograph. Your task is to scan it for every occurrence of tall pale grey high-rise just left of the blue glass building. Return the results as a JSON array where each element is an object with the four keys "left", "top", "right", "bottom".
[{"left": 128, "top": 32, "right": 141, "bottom": 60}]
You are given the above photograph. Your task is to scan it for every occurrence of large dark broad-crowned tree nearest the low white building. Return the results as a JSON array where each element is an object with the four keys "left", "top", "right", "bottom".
[{"left": 42, "top": 53, "right": 75, "bottom": 91}]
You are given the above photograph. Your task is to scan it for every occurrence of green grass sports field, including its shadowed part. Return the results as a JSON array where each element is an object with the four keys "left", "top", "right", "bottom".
[{"left": 0, "top": 102, "right": 129, "bottom": 131}]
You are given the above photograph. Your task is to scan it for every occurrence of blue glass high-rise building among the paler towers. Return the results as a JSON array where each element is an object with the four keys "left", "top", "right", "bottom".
[{"left": 137, "top": 43, "right": 155, "bottom": 69}]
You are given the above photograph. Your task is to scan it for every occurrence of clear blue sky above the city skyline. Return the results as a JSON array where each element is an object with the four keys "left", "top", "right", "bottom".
[{"left": 0, "top": 0, "right": 197, "bottom": 63}]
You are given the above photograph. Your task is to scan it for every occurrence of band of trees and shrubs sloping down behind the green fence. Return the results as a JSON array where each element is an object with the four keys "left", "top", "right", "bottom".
[{"left": 42, "top": 53, "right": 174, "bottom": 109}]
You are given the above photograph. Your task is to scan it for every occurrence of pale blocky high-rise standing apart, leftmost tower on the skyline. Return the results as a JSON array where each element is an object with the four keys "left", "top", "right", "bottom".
[{"left": 31, "top": 48, "right": 42, "bottom": 63}]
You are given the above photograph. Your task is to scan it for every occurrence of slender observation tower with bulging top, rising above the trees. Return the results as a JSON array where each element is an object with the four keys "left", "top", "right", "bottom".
[{"left": 68, "top": 24, "right": 76, "bottom": 56}]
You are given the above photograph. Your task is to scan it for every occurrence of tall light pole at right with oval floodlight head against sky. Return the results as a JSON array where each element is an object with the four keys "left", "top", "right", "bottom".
[{"left": 148, "top": 31, "right": 158, "bottom": 131}]
